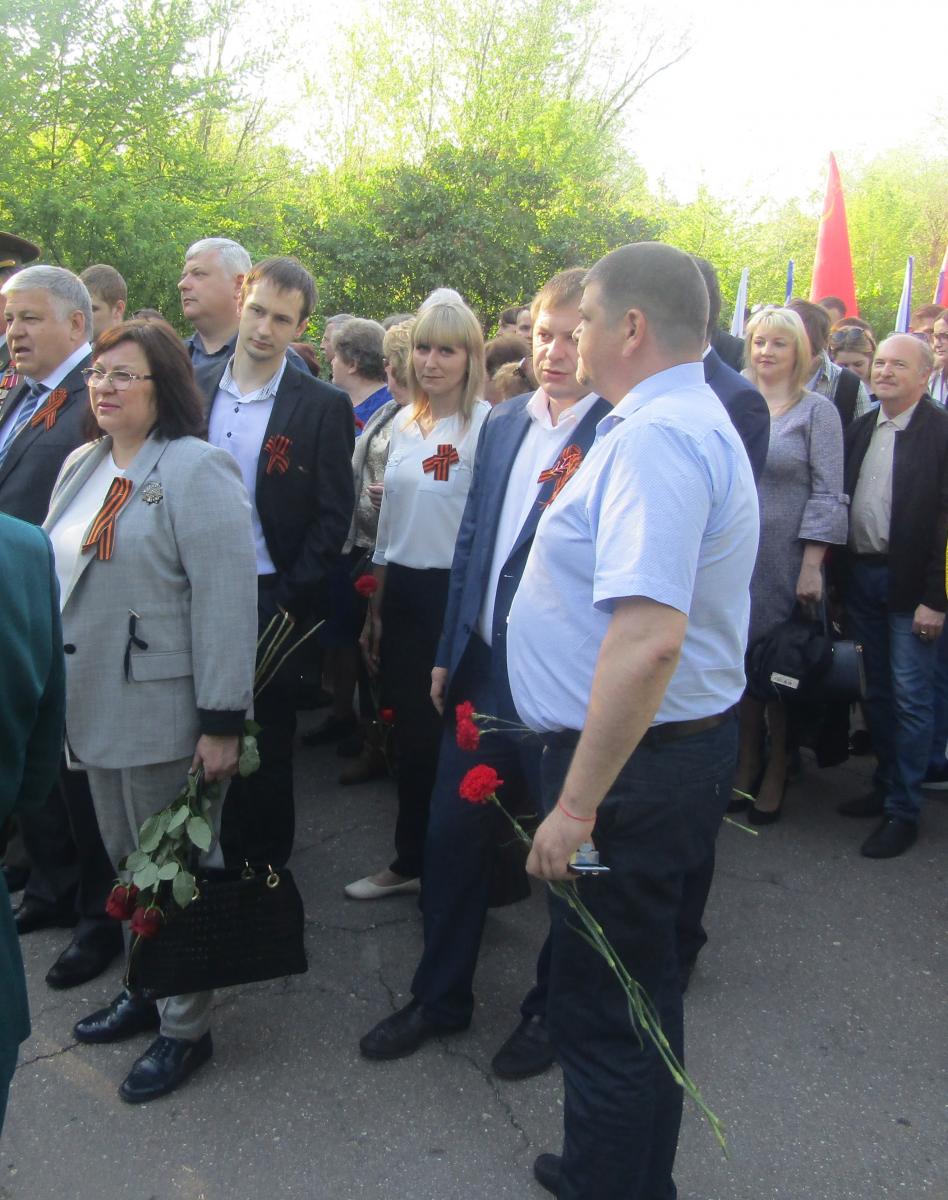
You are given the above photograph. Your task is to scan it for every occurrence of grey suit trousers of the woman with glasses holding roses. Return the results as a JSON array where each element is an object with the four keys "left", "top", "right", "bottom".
[{"left": 89, "top": 758, "right": 223, "bottom": 1042}]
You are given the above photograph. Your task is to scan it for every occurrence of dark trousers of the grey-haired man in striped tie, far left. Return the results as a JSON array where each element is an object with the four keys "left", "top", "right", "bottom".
[{"left": 17, "top": 760, "right": 121, "bottom": 941}]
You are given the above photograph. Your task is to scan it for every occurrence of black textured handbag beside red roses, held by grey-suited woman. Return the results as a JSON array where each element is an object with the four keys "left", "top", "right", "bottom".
[{"left": 125, "top": 866, "right": 307, "bottom": 1000}]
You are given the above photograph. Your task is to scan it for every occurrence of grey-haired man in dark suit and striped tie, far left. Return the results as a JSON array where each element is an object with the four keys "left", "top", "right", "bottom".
[{"left": 0, "top": 265, "right": 121, "bottom": 988}]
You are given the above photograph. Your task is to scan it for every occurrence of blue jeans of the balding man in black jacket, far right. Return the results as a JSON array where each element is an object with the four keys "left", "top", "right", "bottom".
[{"left": 846, "top": 559, "right": 938, "bottom": 821}]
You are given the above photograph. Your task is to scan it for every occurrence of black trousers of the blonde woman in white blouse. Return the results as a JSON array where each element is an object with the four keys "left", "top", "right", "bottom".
[{"left": 382, "top": 563, "right": 451, "bottom": 878}]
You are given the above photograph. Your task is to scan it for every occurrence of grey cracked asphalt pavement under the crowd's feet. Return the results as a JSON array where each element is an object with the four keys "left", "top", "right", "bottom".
[{"left": 0, "top": 716, "right": 948, "bottom": 1200}]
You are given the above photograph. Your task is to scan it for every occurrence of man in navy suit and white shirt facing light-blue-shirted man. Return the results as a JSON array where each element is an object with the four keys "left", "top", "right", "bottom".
[{"left": 360, "top": 268, "right": 610, "bottom": 1079}]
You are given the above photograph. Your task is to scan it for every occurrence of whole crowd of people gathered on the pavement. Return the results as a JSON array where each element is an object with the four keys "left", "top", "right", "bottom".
[{"left": 0, "top": 226, "right": 948, "bottom": 1200}]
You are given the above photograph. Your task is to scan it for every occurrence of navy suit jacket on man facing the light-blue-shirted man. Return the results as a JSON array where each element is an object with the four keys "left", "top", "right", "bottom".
[{"left": 434, "top": 392, "right": 612, "bottom": 691}]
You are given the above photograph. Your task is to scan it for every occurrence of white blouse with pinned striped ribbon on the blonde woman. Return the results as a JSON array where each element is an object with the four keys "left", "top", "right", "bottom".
[{"left": 372, "top": 400, "right": 491, "bottom": 570}]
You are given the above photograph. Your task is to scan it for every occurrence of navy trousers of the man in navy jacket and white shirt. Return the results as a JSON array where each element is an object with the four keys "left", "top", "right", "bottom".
[{"left": 412, "top": 636, "right": 548, "bottom": 1026}]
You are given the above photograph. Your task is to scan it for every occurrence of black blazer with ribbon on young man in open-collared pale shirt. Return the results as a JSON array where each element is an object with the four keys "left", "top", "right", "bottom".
[{"left": 194, "top": 362, "right": 355, "bottom": 620}]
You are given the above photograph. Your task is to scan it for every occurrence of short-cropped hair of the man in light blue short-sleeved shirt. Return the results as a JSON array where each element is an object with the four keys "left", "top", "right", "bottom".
[{"left": 583, "top": 241, "right": 709, "bottom": 360}]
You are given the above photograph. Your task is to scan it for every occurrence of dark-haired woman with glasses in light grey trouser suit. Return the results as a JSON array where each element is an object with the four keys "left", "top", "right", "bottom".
[{"left": 44, "top": 320, "right": 257, "bottom": 1103}]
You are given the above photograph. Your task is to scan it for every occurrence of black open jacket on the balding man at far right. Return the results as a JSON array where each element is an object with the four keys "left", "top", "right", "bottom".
[{"left": 841, "top": 396, "right": 948, "bottom": 612}]
